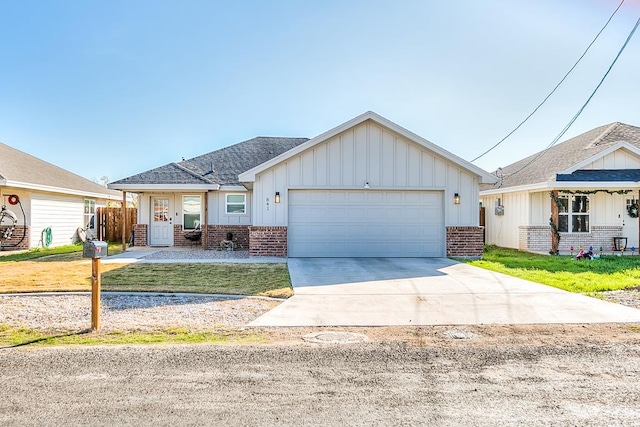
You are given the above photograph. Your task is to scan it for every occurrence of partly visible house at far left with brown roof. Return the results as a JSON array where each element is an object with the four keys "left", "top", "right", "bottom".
[{"left": 0, "top": 143, "right": 122, "bottom": 250}]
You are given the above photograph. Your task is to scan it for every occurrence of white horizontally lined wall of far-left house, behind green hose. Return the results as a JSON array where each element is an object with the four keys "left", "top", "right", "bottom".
[{"left": 30, "top": 193, "right": 84, "bottom": 248}]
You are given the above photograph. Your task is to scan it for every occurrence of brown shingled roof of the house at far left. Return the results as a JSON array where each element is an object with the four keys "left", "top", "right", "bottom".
[{"left": 0, "top": 143, "right": 122, "bottom": 199}]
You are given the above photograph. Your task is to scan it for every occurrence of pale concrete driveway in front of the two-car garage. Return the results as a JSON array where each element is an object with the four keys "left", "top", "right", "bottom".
[{"left": 250, "top": 258, "right": 640, "bottom": 326}]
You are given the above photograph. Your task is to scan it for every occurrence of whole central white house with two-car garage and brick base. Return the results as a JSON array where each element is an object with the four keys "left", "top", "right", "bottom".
[{"left": 109, "top": 112, "right": 496, "bottom": 257}]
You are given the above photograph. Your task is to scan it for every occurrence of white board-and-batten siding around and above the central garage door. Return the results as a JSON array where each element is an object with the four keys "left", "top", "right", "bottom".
[{"left": 252, "top": 121, "right": 479, "bottom": 226}]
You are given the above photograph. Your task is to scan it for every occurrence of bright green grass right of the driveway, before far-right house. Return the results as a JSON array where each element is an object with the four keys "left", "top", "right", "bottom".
[{"left": 465, "top": 246, "right": 640, "bottom": 293}]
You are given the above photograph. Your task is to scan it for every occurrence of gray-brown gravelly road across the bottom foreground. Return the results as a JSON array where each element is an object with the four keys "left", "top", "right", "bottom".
[{"left": 0, "top": 341, "right": 640, "bottom": 426}]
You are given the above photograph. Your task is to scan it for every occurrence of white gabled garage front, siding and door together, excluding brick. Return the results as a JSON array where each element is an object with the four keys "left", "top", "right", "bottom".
[{"left": 252, "top": 121, "right": 479, "bottom": 256}]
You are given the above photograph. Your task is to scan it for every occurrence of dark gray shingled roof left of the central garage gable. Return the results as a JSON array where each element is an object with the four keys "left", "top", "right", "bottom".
[{"left": 109, "top": 136, "right": 309, "bottom": 188}]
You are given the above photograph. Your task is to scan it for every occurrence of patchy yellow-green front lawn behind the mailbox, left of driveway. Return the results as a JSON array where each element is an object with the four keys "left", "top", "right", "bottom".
[{"left": 0, "top": 246, "right": 293, "bottom": 298}]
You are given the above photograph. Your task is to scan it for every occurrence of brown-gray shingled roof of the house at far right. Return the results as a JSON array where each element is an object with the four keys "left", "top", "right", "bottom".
[{"left": 481, "top": 122, "right": 640, "bottom": 190}]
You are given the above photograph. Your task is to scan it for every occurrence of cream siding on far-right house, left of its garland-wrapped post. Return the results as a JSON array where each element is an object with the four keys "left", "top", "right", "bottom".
[{"left": 482, "top": 192, "right": 528, "bottom": 249}]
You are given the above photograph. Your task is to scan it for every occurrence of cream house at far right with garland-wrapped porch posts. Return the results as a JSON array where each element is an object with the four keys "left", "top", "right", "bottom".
[{"left": 480, "top": 123, "right": 640, "bottom": 253}]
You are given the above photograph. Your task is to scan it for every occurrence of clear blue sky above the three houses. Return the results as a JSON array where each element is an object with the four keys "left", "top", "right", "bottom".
[{"left": 0, "top": 0, "right": 640, "bottom": 181}]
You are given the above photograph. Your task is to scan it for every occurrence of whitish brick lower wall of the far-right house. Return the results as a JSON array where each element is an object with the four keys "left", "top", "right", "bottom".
[{"left": 518, "top": 225, "right": 624, "bottom": 253}]
